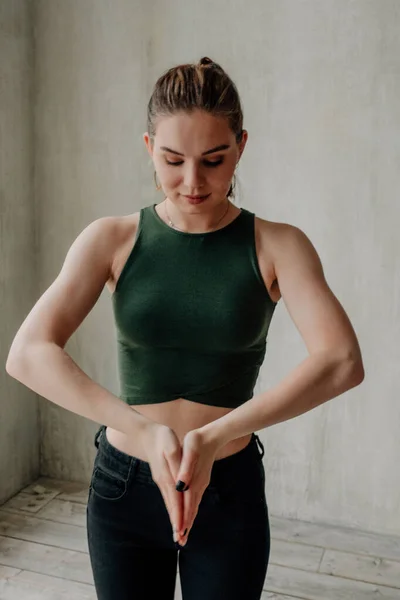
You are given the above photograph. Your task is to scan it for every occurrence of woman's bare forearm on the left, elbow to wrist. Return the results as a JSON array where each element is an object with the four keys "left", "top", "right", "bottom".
[{"left": 6, "top": 342, "right": 154, "bottom": 436}]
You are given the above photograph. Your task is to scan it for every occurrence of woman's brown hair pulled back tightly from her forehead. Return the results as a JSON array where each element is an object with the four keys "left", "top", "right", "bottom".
[{"left": 147, "top": 56, "right": 243, "bottom": 196}]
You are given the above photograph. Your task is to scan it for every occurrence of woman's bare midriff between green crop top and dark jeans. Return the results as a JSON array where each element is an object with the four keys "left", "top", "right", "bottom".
[{"left": 106, "top": 398, "right": 251, "bottom": 460}]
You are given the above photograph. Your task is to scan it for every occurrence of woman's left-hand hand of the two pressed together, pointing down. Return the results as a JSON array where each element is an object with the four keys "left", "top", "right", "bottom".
[{"left": 141, "top": 422, "right": 183, "bottom": 542}]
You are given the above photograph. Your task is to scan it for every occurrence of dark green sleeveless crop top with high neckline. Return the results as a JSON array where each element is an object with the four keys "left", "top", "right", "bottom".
[{"left": 112, "top": 204, "right": 276, "bottom": 408}]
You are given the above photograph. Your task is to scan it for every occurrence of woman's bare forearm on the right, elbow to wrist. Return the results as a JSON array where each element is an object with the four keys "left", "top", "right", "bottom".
[{"left": 200, "top": 353, "right": 363, "bottom": 447}]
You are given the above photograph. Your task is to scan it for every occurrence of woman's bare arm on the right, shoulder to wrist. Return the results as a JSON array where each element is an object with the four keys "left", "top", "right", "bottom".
[{"left": 200, "top": 224, "right": 364, "bottom": 447}]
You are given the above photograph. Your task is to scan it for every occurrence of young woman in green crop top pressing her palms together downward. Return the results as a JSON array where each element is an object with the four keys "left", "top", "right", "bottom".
[{"left": 7, "top": 58, "right": 364, "bottom": 600}]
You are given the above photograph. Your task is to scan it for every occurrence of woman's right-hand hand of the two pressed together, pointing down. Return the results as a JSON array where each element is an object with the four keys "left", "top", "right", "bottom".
[{"left": 176, "top": 429, "right": 220, "bottom": 546}]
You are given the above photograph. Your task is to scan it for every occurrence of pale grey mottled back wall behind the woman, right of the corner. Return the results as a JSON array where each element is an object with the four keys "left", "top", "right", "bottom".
[{"left": 36, "top": 0, "right": 400, "bottom": 533}]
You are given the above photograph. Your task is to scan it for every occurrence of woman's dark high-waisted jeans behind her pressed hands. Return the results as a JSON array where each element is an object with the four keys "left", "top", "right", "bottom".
[{"left": 87, "top": 426, "right": 270, "bottom": 600}]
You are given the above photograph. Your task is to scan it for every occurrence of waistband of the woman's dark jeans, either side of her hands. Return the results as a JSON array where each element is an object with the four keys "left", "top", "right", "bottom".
[{"left": 94, "top": 425, "right": 265, "bottom": 481}]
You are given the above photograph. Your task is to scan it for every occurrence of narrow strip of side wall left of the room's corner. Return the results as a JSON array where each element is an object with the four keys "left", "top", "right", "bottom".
[{"left": 0, "top": 0, "right": 39, "bottom": 503}]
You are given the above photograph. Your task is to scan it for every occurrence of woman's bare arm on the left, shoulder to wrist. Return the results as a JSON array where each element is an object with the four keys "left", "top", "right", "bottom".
[{"left": 6, "top": 217, "right": 154, "bottom": 442}]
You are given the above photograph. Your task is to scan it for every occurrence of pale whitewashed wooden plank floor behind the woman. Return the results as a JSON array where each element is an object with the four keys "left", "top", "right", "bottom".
[{"left": 0, "top": 479, "right": 400, "bottom": 600}]
